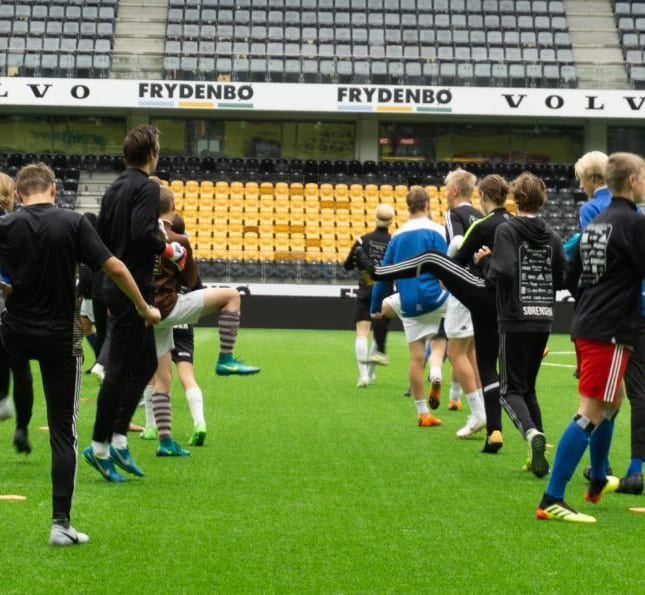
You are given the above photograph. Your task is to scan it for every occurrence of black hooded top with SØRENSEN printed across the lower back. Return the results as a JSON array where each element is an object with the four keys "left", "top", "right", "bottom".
[{"left": 484, "top": 217, "right": 567, "bottom": 332}]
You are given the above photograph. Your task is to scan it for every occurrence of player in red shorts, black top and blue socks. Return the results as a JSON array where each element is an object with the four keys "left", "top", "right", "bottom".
[{"left": 535, "top": 153, "right": 645, "bottom": 523}]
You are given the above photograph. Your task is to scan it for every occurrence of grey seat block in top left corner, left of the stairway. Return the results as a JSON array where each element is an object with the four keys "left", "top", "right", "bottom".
[{"left": 0, "top": 0, "right": 118, "bottom": 78}]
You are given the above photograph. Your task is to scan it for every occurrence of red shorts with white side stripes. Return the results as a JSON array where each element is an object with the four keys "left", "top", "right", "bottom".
[{"left": 575, "top": 339, "right": 631, "bottom": 403}]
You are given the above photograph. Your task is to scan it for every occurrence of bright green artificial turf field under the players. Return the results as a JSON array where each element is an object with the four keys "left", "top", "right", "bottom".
[{"left": 0, "top": 329, "right": 645, "bottom": 593}]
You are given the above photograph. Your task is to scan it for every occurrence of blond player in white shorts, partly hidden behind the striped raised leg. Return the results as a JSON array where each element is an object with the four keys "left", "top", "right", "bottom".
[{"left": 445, "top": 169, "right": 486, "bottom": 438}]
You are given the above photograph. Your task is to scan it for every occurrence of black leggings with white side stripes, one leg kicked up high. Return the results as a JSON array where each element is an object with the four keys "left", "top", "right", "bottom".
[{"left": 374, "top": 250, "right": 502, "bottom": 435}]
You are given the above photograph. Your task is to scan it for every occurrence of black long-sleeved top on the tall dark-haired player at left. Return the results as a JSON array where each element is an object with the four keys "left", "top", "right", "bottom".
[{"left": 98, "top": 169, "right": 165, "bottom": 300}]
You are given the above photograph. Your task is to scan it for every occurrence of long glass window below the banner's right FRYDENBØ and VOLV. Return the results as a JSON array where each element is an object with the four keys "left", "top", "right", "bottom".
[{"left": 378, "top": 122, "right": 584, "bottom": 163}]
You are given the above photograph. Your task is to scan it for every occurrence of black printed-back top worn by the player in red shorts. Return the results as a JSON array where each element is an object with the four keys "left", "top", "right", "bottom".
[{"left": 569, "top": 196, "right": 645, "bottom": 346}]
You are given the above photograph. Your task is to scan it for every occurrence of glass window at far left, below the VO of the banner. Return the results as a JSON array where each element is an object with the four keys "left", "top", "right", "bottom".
[{"left": 0, "top": 115, "right": 126, "bottom": 155}]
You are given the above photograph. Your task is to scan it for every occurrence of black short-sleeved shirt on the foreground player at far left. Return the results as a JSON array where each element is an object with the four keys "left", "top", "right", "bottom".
[{"left": 0, "top": 204, "right": 112, "bottom": 336}]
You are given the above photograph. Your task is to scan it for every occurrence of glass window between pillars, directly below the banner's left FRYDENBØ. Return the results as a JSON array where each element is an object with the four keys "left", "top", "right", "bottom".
[{"left": 151, "top": 118, "right": 356, "bottom": 159}]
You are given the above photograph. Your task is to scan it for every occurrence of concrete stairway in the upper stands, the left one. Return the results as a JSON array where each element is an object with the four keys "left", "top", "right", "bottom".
[{"left": 111, "top": 0, "right": 168, "bottom": 79}]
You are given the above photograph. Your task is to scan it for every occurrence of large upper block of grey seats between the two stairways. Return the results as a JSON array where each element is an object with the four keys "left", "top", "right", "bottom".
[{"left": 163, "top": 0, "right": 577, "bottom": 87}]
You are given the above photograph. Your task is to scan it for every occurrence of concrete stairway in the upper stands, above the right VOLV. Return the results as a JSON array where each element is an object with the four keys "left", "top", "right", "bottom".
[{"left": 564, "top": 0, "right": 630, "bottom": 89}]
